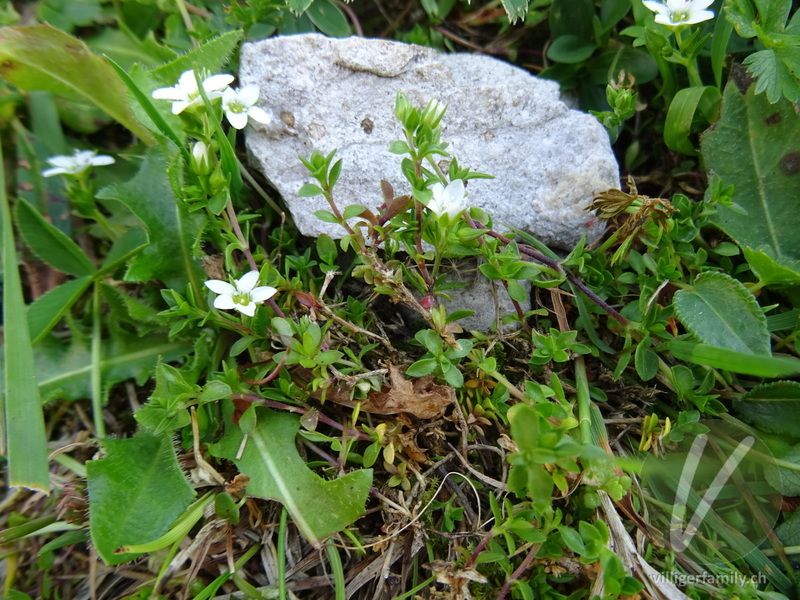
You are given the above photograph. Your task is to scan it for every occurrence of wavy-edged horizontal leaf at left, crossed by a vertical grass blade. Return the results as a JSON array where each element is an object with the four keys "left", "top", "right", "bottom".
[{"left": 25, "top": 334, "right": 192, "bottom": 402}]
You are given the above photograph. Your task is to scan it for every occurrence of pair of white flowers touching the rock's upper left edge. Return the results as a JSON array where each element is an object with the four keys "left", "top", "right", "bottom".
[{"left": 152, "top": 71, "right": 271, "bottom": 129}]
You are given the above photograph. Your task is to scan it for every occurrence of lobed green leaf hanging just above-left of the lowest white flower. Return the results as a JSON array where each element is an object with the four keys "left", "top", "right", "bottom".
[{"left": 98, "top": 148, "right": 202, "bottom": 288}]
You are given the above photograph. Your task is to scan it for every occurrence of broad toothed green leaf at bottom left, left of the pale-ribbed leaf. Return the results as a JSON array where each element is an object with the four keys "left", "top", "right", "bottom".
[{"left": 86, "top": 432, "right": 194, "bottom": 565}]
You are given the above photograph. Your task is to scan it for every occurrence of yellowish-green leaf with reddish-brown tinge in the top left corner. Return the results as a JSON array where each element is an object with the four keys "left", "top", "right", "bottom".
[{"left": 0, "top": 24, "right": 155, "bottom": 143}]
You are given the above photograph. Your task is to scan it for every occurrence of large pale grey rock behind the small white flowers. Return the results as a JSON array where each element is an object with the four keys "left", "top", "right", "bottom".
[{"left": 240, "top": 34, "right": 619, "bottom": 249}]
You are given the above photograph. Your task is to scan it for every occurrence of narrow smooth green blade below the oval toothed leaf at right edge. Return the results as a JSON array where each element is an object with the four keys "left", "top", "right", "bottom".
[{"left": 668, "top": 340, "right": 800, "bottom": 377}]
